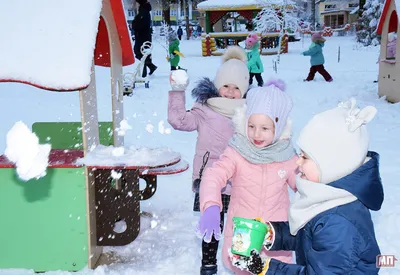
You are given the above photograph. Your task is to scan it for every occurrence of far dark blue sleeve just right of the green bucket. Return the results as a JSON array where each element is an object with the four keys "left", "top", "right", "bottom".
[{"left": 269, "top": 222, "right": 296, "bottom": 251}]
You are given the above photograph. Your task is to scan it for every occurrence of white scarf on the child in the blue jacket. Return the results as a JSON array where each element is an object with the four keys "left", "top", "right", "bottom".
[{"left": 289, "top": 175, "right": 357, "bottom": 235}]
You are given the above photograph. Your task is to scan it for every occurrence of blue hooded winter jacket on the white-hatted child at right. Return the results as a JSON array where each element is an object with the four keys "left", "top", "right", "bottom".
[{"left": 267, "top": 152, "right": 383, "bottom": 275}]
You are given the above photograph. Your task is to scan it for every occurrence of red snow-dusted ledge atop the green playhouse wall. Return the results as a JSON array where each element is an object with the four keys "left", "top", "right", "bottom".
[{"left": 0, "top": 149, "right": 83, "bottom": 168}]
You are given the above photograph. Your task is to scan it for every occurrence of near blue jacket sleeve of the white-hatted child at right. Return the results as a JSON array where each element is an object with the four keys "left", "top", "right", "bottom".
[{"left": 266, "top": 214, "right": 364, "bottom": 275}]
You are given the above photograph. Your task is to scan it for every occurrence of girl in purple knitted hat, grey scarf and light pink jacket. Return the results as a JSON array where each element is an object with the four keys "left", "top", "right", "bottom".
[{"left": 199, "top": 82, "right": 297, "bottom": 274}]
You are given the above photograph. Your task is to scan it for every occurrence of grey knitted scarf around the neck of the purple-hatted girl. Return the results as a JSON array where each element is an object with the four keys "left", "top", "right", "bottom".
[{"left": 229, "top": 133, "right": 295, "bottom": 164}]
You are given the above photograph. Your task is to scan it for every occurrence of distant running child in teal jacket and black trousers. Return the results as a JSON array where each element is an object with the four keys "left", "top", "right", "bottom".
[{"left": 302, "top": 32, "right": 333, "bottom": 82}]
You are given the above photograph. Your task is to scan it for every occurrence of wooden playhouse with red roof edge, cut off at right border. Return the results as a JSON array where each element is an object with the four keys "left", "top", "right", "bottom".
[{"left": 376, "top": 0, "right": 400, "bottom": 102}]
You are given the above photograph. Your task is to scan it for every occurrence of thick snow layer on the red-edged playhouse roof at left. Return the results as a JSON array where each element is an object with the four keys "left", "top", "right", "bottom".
[{"left": 0, "top": 0, "right": 102, "bottom": 90}]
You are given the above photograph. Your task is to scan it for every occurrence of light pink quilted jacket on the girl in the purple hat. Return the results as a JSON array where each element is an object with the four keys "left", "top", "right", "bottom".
[{"left": 200, "top": 146, "right": 298, "bottom": 274}]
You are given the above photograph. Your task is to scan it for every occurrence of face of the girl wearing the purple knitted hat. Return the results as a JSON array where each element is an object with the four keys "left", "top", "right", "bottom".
[{"left": 247, "top": 114, "right": 275, "bottom": 148}]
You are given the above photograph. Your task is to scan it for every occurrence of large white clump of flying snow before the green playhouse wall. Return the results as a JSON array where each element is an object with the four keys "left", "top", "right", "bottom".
[{"left": 4, "top": 121, "right": 51, "bottom": 181}]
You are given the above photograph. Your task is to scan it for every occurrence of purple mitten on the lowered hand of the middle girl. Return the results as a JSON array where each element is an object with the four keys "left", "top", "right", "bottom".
[{"left": 198, "top": 205, "right": 221, "bottom": 243}]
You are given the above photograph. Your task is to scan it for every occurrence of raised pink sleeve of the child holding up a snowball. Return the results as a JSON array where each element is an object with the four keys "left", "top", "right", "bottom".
[{"left": 168, "top": 91, "right": 198, "bottom": 132}]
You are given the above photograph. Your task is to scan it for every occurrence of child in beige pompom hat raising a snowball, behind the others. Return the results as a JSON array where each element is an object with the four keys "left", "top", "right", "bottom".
[{"left": 168, "top": 46, "right": 249, "bottom": 275}]
